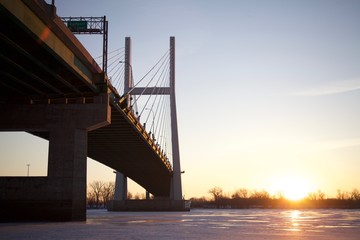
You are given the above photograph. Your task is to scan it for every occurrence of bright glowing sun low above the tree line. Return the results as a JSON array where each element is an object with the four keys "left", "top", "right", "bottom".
[{"left": 277, "top": 176, "right": 310, "bottom": 201}]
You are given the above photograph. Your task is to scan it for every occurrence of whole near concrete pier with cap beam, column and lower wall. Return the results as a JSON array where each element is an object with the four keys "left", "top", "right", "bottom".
[{"left": 0, "top": 95, "right": 111, "bottom": 221}]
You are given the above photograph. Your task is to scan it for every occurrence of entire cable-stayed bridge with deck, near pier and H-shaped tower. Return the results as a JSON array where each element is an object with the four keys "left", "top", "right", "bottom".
[{"left": 0, "top": 0, "right": 185, "bottom": 221}]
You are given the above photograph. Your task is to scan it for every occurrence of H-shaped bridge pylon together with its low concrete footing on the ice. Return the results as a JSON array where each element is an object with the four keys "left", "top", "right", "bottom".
[{"left": 111, "top": 37, "right": 189, "bottom": 210}]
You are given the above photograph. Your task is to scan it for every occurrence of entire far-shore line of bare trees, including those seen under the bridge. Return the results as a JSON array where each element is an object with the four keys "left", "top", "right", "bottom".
[{"left": 87, "top": 181, "right": 360, "bottom": 208}]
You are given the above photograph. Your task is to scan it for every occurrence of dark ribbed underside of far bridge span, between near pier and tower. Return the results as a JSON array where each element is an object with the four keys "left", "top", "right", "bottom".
[{"left": 88, "top": 107, "right": 171, "bottom": 197}]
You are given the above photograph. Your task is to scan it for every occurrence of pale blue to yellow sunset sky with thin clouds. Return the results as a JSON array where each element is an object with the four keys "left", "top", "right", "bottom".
[{"left": 0, "top": 0, "right": 360, "bottom": 198}]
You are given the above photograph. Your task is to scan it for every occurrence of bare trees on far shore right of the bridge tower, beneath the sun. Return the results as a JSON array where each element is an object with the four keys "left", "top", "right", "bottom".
[{"left": 190, "top": 187, "right": 360, "bottom": 208}]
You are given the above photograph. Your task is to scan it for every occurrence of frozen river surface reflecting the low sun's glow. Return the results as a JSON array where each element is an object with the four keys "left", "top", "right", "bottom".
[{"left": 0, "top": 209, "right": 360, "bottom": 240}]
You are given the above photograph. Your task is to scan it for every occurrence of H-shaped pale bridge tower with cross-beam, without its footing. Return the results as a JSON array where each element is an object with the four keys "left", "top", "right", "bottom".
[{"left": 115, "top": 37, "right": 182, "bottom": 200}]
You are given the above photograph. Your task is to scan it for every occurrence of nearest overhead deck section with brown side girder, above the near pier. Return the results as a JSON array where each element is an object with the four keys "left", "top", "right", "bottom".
[{"left": 0, "top": 1, "right": 103, "bottom": 101}]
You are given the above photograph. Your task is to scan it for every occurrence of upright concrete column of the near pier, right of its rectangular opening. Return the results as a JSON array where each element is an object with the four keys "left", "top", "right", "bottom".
[{"left": 48, "top": 125, "right": 87, "bottom": 220}]
